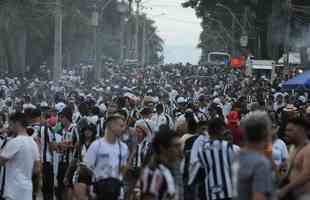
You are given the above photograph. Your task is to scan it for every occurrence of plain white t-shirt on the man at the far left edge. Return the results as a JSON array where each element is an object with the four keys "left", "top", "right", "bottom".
[{"left": 1, "top": 136, "right": 40, "bottom": 200}]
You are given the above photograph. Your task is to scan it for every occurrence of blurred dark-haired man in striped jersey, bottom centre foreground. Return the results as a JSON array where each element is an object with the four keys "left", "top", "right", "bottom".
[{"left": 139, "top": 127, "right": 181, "bottom": 200}]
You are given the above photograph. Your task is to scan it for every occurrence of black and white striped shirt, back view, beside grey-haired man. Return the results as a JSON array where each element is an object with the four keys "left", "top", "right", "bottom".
[{"left": 198, "top": 140, "right": 239, "bottom": 200}]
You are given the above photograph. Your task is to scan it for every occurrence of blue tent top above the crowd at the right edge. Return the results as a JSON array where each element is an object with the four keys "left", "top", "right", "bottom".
[{"left": 282, "top": 70, "right": 310, "bottom": 90}]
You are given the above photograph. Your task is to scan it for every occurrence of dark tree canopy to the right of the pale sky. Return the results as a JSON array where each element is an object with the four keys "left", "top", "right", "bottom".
[{"left": 182, "top": 0, "right": 310, "bottom": 60}]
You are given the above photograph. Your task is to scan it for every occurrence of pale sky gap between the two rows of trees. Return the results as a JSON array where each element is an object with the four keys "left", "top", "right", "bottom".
[{"left": 142, "top": 0, "right": 201, "bottom": 64}]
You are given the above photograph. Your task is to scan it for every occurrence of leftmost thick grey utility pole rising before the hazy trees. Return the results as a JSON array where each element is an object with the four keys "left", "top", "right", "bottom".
[{"left": 53, "top": 0, "right": 62, "bottom": 81}]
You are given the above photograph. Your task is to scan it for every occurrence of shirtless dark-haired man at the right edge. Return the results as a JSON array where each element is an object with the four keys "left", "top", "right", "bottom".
[{"left": 279, "top": 118, "right": 310, "bottom": 199}]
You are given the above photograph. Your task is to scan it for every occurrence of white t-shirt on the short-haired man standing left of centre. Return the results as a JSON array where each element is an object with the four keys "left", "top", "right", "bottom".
[{"left": 84, "top": 138, "right": 128, "bottom": 181}]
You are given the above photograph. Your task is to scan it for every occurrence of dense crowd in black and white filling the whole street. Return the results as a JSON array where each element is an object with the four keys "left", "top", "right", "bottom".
[{"left": 0, "top": 64, "right": 310, "bottom": 200}]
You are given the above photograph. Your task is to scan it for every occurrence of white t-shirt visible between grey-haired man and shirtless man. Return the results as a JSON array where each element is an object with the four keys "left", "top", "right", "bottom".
[{"left": 272, "top": 139, "right": 288, "bottom": 167}]
